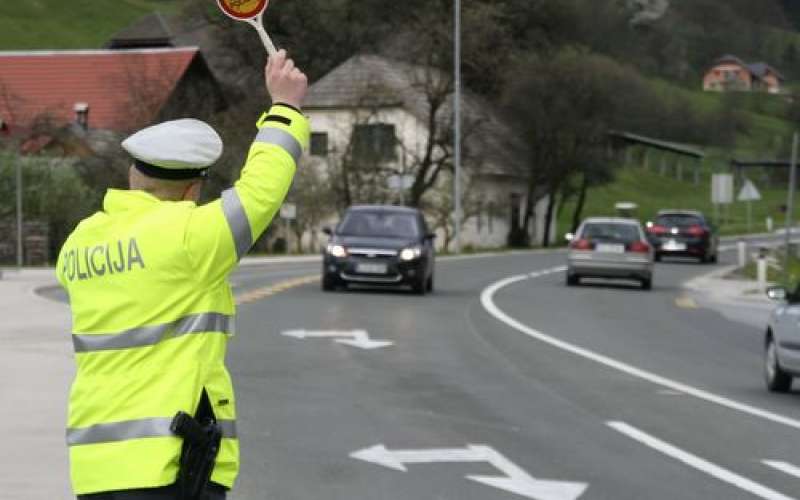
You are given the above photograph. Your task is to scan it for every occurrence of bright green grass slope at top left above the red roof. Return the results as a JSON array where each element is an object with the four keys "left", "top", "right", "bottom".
[{"left": 0, "top": 0, "right": 179, "bottom": 50}]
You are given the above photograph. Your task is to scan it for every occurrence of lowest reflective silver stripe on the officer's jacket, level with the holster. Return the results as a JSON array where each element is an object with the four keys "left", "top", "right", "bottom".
[{"left": 67, "top": 418, "right": 237, "bottom": 446}]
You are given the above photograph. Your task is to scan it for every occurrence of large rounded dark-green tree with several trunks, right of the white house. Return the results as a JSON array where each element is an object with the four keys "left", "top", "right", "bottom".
[{"left": 504, "top": 50, "right": 647, "bottom": 246}]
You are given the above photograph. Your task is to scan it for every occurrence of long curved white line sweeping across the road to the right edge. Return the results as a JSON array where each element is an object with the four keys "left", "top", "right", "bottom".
[{"left": 481, "top": 266, "right": 800, "bottom": 429}]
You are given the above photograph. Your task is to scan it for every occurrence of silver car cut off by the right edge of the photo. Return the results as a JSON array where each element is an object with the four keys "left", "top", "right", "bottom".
[{"left": 764, "top": 287, "right": 800, "bottom": 392}]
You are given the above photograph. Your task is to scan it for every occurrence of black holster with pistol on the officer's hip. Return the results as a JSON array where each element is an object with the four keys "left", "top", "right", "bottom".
[{"left": 170, "top": 391, "right": 222, "bottom": 500}]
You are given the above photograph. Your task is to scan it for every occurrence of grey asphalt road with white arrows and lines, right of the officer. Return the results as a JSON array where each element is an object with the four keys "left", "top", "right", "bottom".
[{"left": 228, "top": 244, "right": 800, "bottom": 500}]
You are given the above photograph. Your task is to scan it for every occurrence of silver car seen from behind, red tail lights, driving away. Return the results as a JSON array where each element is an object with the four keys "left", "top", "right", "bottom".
[{"left": 566, "top": 217, "right": 655, "bottom": 290}]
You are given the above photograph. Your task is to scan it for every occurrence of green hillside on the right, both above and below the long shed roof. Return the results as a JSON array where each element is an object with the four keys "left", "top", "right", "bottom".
[{"left": 559, "top": 71, "right": 795, "bottom": 240}]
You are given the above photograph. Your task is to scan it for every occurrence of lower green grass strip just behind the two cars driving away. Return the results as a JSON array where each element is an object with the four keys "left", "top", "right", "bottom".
[{"left": 558, "top": 165, "right": 786, "bottom": 234}]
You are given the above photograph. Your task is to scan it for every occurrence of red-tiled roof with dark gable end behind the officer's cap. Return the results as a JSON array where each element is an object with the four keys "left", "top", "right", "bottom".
[{"left": 0, "top": 47, "right": 225, "bottom": 134}]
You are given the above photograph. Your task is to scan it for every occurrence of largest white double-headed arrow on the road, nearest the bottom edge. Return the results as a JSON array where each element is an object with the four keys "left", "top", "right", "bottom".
[{"left": 350, "top": 444, "right": 589, "bottom": 500}]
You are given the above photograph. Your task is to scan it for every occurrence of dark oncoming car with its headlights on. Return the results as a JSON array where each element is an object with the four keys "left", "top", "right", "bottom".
[{"left": 322, "top": 205, "right": 435, "bottom": 295}]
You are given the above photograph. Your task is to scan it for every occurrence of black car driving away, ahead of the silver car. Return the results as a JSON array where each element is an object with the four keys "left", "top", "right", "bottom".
[{"left": 646, "top": 210, "right": 719, "bottom": 262}]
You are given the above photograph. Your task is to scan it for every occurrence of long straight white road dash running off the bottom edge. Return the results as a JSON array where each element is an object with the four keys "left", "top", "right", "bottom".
[{"left": 606, "top": 422, "right": 794, "bottom": 500}]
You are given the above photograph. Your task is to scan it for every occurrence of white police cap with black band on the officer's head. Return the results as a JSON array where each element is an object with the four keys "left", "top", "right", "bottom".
[{"left": 122, "top": 118, "right": 222, "bottom": 179}]
